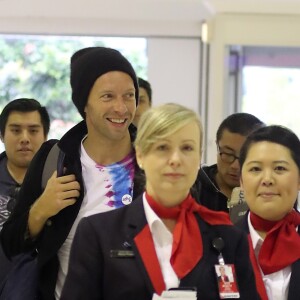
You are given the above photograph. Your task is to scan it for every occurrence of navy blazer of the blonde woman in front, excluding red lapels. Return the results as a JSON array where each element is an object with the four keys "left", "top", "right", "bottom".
[{"left": 61, "top": 196, "right": 259, "bottom": 300}]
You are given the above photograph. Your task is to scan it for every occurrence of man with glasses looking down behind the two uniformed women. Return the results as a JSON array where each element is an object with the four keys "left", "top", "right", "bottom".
[{"left": 198, "top": 113, "right": 264, "bottom": 212}]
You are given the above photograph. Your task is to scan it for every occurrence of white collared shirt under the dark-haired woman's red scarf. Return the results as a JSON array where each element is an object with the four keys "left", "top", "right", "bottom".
[{"left": 248, "top": 214, "right": 292, "bottom": 300}]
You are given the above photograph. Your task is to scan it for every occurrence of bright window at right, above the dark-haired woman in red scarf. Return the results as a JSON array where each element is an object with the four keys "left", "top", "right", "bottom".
[{"left": 239, "top": 46, "right": 300, "bottom": 137}]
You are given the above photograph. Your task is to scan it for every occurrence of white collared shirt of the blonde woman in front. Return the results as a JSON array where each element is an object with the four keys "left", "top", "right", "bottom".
[{"left": 143, "top": 193, "right": 180, "bottom": 290}]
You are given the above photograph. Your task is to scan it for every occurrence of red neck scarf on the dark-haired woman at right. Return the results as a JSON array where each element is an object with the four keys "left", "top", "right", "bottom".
[{"left": 250, "top": 210, "right": 300, "bottom": 275}]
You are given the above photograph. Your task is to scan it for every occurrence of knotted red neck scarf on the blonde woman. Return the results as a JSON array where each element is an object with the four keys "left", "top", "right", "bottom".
[{"left": 146, "top": 193, "right": 232, "bottom": 279}]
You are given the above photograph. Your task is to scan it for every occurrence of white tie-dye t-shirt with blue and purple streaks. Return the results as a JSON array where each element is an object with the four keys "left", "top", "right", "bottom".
[{"left": 55, "top": 140, "right": 136, "bottom": 299}]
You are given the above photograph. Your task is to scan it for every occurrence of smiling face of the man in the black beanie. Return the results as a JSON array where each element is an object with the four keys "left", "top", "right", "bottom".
[{"left": 84, "top": 71, "right": 136, "bottom": 142}]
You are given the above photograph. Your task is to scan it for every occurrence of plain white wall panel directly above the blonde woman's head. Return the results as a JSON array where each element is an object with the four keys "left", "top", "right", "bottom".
[{"left": 148, "top": 38, "right": 200, "bottom": 112}]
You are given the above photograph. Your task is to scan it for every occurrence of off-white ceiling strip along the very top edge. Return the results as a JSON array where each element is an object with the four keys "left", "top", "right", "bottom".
[{"left": 0, "top": 0, "right": 300, "bottom": 21}]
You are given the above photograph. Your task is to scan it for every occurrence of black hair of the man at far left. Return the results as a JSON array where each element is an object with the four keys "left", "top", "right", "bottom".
[{"left": 0, "top": 98, "right": 50, "bottom": 137}]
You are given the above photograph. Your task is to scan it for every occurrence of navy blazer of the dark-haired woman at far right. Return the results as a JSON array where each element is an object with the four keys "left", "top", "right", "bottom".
[{"left": 236, "top": 212, "right": 300, "bottom": 300}]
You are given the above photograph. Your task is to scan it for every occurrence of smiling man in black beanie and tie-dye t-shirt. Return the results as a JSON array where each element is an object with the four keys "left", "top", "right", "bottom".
[{"left": 1, "top": 47, "right": 143, "bottom": 300}]
